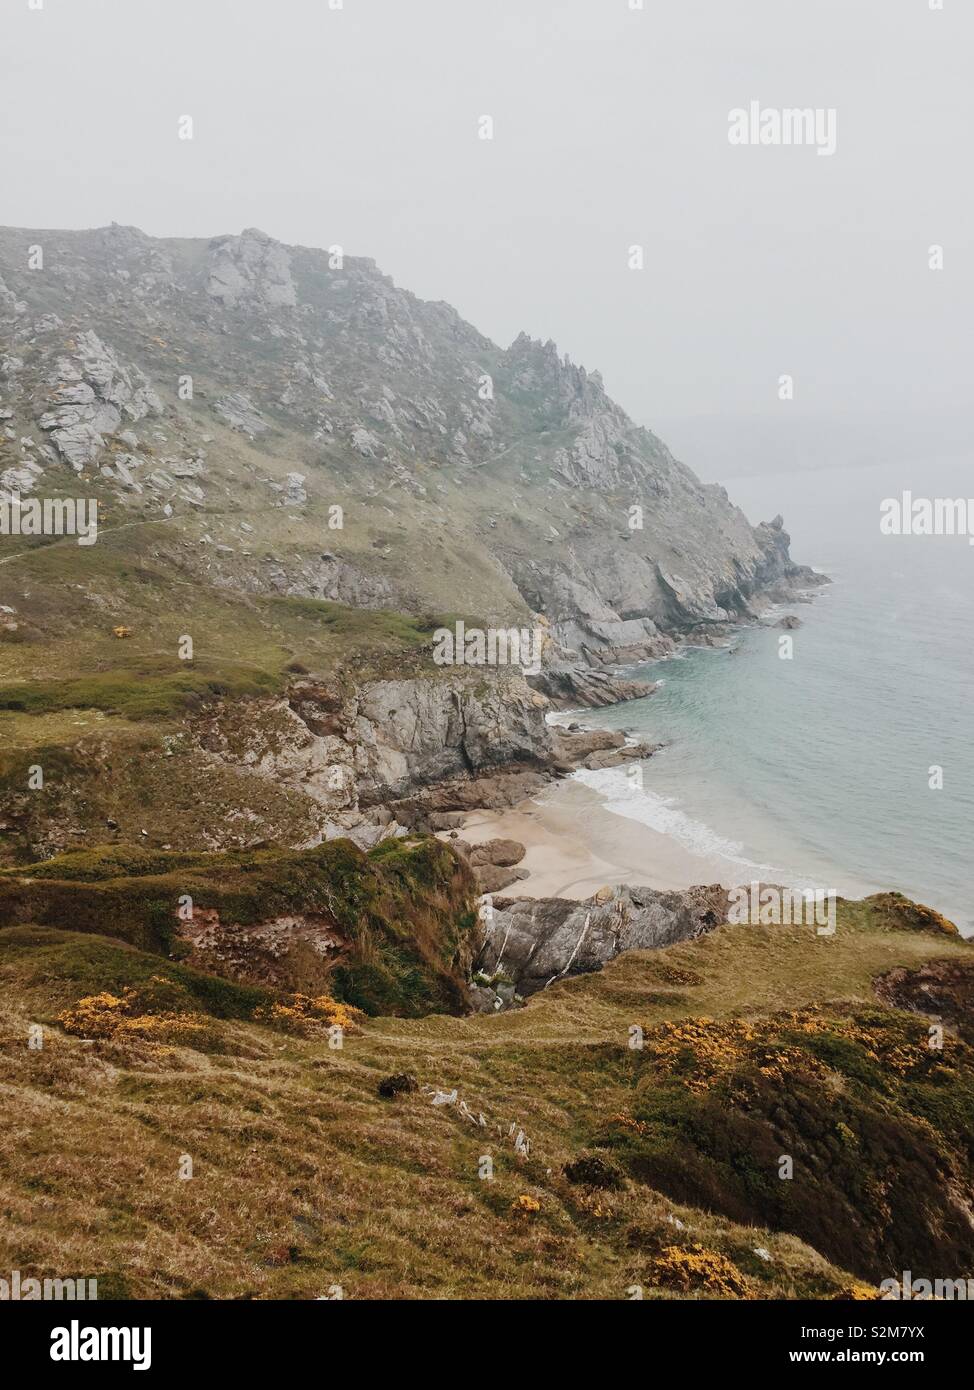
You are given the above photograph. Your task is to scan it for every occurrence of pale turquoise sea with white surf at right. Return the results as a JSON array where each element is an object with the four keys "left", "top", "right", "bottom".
[{"left": 566, "top": 463, "right": 974, "bottom": 933}]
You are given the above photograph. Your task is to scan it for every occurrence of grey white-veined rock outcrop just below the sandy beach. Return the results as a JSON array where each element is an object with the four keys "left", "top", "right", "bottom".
[{"left": 475, "top": 885, "right": 728, "bottom": 997}]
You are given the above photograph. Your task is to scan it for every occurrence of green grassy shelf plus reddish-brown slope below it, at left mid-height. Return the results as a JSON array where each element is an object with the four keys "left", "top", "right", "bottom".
[{"left": 0, "top": 517, "right": 472, "bottom": 863}]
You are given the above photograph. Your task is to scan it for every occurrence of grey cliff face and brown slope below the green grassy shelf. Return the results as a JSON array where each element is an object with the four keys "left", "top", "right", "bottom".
[{"left": 0, "top": 674, "right": 561, "bottom": 863}]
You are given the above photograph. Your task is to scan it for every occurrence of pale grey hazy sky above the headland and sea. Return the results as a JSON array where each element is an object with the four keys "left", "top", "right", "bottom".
[{"left": 0, "top": 0, "right": 974, "bottom": 477}]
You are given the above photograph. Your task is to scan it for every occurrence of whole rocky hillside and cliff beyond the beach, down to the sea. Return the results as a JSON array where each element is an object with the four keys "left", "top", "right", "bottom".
[{"left": 0, "top": 225, "right": 814, "bottom": 863}]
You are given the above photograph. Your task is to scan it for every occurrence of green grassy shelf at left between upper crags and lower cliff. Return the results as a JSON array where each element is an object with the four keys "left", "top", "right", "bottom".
[{"left": 0, "top": 513, "right": 458, "bottom": 695}]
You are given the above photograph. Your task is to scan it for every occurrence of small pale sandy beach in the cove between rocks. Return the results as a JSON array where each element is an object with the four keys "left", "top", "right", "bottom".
[{"left": 443, "top": 778, "right": 728, "bottom": 898}]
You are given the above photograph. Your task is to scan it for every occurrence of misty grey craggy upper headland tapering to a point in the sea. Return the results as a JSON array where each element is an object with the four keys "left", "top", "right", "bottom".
[{"left": 0, "top": 225, "right": 813, "bottom": 666}]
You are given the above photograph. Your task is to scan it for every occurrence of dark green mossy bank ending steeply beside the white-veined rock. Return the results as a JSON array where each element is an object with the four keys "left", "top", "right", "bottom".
[{"left": 0, "top": 838, "right": 475, "bottom": 1015}]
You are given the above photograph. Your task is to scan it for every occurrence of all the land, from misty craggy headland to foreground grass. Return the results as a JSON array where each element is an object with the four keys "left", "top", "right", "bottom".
[{"left": 0, "top": 224, "right": 974, "bottom": 1298}]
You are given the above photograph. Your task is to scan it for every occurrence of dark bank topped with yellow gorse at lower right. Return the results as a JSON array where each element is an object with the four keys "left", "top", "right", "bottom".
[{"left": 599, "top": 1004, "right": 974, "bottom": 1282}]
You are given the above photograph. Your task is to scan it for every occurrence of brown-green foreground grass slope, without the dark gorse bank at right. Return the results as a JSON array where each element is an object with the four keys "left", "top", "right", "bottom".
[{"left": 0, "top": 904, "right": 970, "bottom": 1298}]
